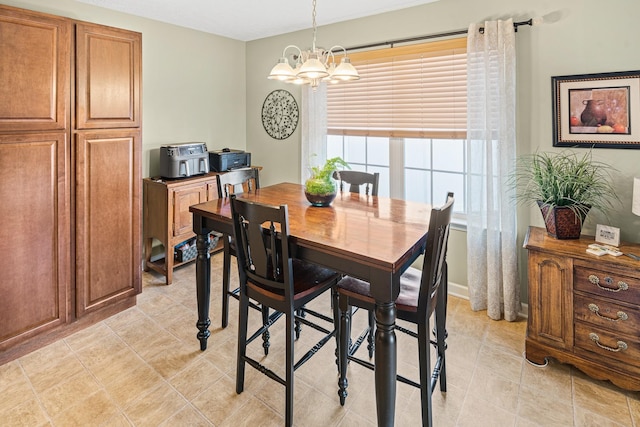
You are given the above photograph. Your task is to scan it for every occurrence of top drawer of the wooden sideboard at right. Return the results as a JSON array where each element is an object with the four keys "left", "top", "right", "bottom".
[{"left": 573, "top": 265, "right": 640, "bottom": 305}]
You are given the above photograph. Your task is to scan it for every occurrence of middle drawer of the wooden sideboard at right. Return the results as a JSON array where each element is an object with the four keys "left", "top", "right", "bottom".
[{"left": 573, "top": 293, "right": 640, "bottom": 335}]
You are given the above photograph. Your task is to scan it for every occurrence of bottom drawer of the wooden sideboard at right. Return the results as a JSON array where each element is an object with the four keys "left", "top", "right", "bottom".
[{"left": 575, "top": 322, "right": 640, "bottom": 367}]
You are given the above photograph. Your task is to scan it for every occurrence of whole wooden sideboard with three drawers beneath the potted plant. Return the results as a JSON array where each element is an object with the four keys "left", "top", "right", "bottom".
[{"left": 524, "top": 227, "right": 640, "bottom": 391}]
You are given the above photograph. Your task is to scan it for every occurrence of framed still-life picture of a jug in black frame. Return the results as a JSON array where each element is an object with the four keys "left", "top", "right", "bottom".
[{"left": 551, "top": 70, "right": 640, "bottom": 148}]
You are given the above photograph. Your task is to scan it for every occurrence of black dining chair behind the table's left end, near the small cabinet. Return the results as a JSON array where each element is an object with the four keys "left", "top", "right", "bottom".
[{"left": 218, "top": 168, "right": 260, "bottom": 328}]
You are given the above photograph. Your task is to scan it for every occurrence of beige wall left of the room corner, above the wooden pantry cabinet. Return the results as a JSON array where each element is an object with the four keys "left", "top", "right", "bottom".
[{"left": 1, "top": 0, "right": 246, "bottom": 177}]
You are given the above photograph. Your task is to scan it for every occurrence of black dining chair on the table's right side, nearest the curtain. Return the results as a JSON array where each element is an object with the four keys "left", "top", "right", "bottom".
[{"left": 337, "top": 193, "right": 454, "bottom": 426}]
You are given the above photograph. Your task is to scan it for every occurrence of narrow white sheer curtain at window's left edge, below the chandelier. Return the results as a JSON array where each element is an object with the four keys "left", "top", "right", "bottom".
[{"left": 300, "top": 84, "right": 327, "bottom": 183}]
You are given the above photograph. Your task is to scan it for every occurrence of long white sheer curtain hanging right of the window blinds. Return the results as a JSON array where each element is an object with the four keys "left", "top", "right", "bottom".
[{"left": 467, "top": 19, "right": 521, "bottom": 321}]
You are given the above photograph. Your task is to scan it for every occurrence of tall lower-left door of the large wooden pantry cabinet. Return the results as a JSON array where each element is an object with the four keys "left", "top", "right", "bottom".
[{"left": 0, "top": 133, "right": 70, "bottom": 350}]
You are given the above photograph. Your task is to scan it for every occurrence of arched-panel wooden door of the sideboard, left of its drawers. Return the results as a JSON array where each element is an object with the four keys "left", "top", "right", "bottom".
[{"left": 528, "top": 250, "right": 573, "bottom": 350}]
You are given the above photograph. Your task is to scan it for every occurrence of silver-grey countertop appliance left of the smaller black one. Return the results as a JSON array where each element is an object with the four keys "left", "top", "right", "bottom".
[{"left": 160, "top": 142, "right": 209, "bottom": 178}]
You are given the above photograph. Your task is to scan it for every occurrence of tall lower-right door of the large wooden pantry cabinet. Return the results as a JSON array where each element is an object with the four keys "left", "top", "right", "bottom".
[{"left": 75, "top": 129, "right": 142, "bottom": 316}]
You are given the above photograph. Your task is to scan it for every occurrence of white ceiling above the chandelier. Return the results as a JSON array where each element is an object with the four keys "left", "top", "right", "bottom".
[{"left": 76, "top": 0, "right": 438, "bottom": 41}]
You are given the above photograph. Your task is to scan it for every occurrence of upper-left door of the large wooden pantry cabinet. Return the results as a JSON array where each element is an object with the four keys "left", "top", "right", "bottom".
[{"left": 0, "top": 5, "right": 72, "bottom": 132}]
